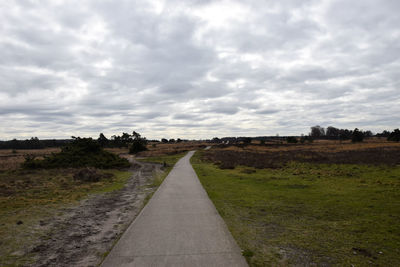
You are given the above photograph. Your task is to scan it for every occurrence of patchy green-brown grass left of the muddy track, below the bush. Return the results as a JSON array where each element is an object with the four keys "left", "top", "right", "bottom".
[{"left": 0, "top": 169, "right": 132, "bottom": 266}]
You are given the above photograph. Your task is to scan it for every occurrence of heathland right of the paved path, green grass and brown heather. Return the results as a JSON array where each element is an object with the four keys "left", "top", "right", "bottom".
[{"left": 192, "top": 137, "right": 400, "bottom": 266}]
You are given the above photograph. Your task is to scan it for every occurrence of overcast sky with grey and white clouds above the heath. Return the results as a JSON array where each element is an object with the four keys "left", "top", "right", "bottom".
[{"left": 0, "top": 0, "right": 400, "bottom": 140}]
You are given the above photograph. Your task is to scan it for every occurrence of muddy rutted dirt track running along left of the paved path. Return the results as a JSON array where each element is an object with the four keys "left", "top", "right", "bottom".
[{"left": 28, "top": 158, "right": 161, "bottom": 267}]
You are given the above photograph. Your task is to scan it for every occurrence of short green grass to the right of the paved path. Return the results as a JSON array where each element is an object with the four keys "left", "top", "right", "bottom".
[{"left": 192, "top": 152, "right": 400, "bottom": 266}]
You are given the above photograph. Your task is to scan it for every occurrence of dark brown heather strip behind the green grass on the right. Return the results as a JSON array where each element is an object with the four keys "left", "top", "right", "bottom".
[{"left": 204, "top": 139, "right": 400, "bottom": 169}]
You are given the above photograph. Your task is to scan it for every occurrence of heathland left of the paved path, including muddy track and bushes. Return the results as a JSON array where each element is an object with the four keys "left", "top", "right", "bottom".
[{"left": 0, "top": 129, "right": 209, "bottom": 266}]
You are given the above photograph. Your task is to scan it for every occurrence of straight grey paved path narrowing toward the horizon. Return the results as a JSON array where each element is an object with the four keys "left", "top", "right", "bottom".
[{"left": 102, "top": 151, "right": 247, "bottom": 267}]
